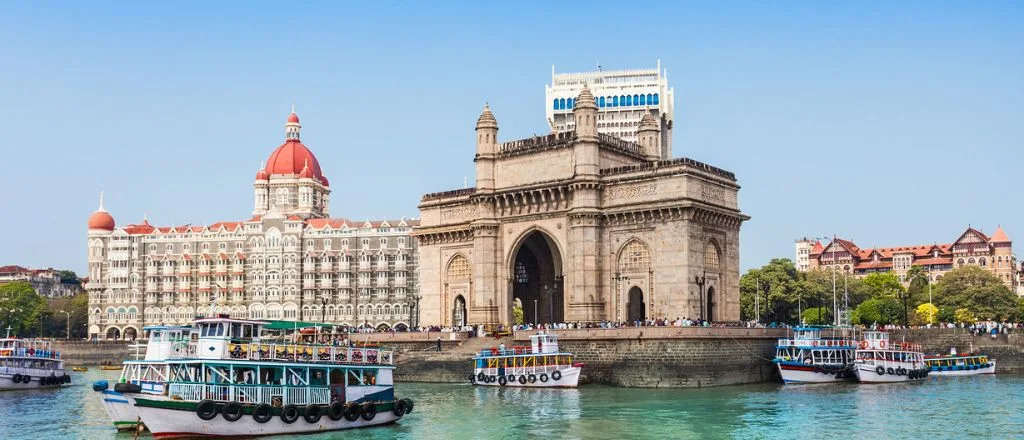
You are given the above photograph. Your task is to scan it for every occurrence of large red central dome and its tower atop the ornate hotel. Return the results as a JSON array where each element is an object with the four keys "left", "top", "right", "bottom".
[{"left": 253, "top": 111, "right": 331, "bottom": 218}]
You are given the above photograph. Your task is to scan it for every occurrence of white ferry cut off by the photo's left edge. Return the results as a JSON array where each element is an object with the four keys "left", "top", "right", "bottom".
[{"left": 0, "top": 335, "right": 71, "bottom": 391}]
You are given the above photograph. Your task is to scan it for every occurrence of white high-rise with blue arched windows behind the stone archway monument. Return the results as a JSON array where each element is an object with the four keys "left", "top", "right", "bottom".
[{"left": 545, "top": 60, "right": 675, "bottom": 160}]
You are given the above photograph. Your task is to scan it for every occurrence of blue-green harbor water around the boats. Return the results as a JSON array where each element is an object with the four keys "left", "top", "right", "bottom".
[{"left": 0, "top": 369, "right": 1024, "bottom": 440}]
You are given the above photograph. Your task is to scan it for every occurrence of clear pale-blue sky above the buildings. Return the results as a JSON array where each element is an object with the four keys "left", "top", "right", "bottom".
[{"left": 0, "top": 1, "right": 1024, "bottom": 273}]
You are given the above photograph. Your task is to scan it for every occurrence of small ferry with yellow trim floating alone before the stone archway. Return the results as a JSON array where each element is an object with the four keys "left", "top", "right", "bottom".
[{"left": 469, "top": 334, "right": 584, "bottom": 388}]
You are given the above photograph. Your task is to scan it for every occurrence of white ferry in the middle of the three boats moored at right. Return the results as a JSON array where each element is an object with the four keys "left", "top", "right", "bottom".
[{"left": 854, "top": 331, "right": 928, "bottom": 384}]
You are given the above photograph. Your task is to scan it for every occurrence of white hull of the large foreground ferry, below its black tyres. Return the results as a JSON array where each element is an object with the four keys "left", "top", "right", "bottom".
[{"left": 135, "top": 399, "right": 401, "bottom": 439}]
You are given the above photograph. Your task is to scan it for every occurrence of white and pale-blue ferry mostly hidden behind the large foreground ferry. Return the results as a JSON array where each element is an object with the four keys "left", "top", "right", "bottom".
[{"left": 92, "top": 325, "right": 196, "bottom": 431}]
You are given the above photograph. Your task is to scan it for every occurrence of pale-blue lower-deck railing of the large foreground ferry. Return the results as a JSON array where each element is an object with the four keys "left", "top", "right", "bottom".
[{"left": 167, "top": 384, "right": 331, "bottom": 406}]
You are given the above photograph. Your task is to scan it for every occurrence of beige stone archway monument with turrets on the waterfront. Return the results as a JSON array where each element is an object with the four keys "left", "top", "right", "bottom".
[{"left": 414, "top": 87, "right": 749, "bottom": 325}]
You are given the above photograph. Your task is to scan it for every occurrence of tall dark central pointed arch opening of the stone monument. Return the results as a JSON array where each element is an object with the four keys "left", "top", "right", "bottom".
[{"left": 509, "top": 230, "right": 565, "bottom": 324}]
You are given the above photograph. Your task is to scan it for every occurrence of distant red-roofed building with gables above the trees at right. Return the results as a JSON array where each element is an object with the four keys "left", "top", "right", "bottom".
[{"left": 797, "top": 227, "right": 1019, "bottom": 291}]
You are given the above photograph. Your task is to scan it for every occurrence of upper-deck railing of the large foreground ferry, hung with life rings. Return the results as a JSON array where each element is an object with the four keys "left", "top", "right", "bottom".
[{"left": 218, "top": 343, "right": 394, "bottom": 365}]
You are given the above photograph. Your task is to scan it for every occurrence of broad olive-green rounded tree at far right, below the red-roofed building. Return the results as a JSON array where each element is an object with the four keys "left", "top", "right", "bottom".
[{"left": 933, "top": 266, "right": 1019, "bottom": 320}]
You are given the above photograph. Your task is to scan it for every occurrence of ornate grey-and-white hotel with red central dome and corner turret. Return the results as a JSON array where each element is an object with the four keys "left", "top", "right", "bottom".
[{"left": 85, "top": 112, "right": 419, "bottom": 340}]
